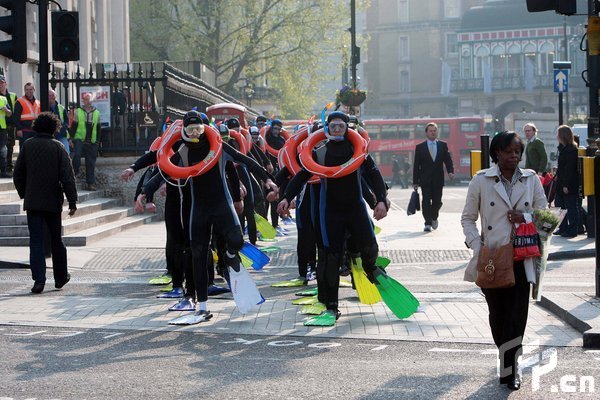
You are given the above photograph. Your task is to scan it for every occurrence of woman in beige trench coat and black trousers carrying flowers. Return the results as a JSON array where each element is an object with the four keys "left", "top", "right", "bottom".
[{"left": 461, "top": 132, "right": 548, "bottom": 390}]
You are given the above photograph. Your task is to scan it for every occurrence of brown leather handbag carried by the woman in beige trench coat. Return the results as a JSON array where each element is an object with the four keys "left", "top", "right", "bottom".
[{"left": 475, "top": 225, "right": 515, "bottom": 289}]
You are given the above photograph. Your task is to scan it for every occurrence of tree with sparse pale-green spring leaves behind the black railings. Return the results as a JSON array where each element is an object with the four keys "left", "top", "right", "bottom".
[{"left": 131, "top": 0, "right": 360, "bottom": 116}]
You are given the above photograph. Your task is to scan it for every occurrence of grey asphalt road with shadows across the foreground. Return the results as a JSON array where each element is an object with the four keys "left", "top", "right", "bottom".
[{"left": 0, "top": 326, "right": 600, "bottom": 400}]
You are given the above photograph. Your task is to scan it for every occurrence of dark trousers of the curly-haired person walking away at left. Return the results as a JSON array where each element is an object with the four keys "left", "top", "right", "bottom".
[{"left": 27, "top": 210, "right": 68, "bottom": 283}]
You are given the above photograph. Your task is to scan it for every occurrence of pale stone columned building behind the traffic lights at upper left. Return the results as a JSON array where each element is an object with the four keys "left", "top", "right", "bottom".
[{"left": 0, "top": 0, "right": 130, "bottom": 95}]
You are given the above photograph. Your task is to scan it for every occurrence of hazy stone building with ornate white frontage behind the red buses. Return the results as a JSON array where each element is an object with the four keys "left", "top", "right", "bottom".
[{"left": 364, "top": 0, "right": 587, "bottom": 125}]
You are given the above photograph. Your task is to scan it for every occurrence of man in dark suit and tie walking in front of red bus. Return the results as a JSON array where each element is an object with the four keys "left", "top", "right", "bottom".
[{"left": 413, "top": 122, "right": 454, "bottom": 232}]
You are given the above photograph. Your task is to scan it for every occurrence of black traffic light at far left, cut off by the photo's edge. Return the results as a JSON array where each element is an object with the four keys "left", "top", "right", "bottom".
[{"left": 0, "top": 0, "right": 27, "bottom": 63}]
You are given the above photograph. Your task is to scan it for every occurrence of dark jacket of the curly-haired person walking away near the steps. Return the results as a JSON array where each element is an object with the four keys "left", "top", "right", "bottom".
[{"left": 13, "top": 133, "right": 77, "bottom": 212}]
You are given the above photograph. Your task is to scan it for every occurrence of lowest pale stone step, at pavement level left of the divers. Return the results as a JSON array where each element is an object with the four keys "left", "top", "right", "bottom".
[{"left": 0, "top": 214, "right": 158, "bottom": 247}]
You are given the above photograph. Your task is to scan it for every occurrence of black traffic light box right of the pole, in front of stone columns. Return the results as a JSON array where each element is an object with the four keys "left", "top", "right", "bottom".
[{"left": 52, "top": 11, "right": 79, "bottom": 62}]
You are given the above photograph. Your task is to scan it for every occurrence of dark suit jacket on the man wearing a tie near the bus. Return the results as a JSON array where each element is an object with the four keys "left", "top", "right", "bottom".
[{"left": 413, "top": 140, "right": 454, "bottom": 186}]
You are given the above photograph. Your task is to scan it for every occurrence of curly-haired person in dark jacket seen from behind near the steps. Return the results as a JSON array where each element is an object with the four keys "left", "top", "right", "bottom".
[{"left": 13, "top": 112, "right": 77, "bottom": 293}]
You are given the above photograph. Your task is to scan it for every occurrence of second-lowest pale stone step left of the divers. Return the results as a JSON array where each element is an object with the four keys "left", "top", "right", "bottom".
[{"left": 0, "top": 207, "right": 133, "bottom": 237}]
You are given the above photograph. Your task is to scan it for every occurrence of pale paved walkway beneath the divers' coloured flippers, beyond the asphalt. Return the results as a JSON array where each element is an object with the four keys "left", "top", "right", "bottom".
[{"left": 0, "top": 198, "right": 600, "bottom": 347}]
